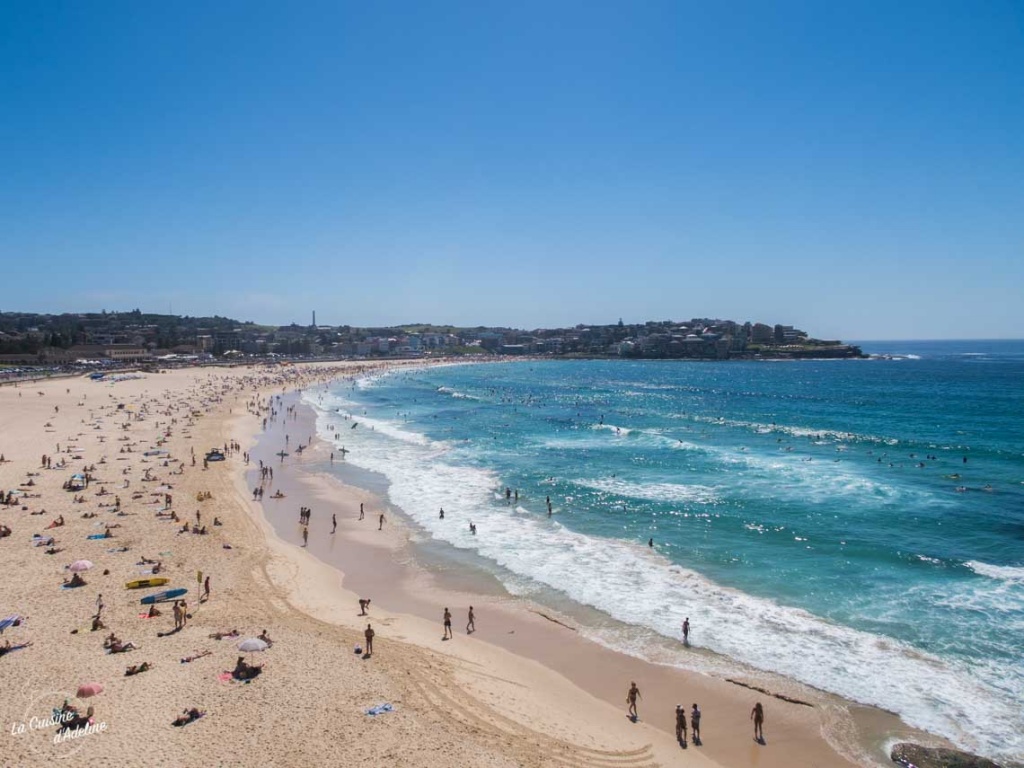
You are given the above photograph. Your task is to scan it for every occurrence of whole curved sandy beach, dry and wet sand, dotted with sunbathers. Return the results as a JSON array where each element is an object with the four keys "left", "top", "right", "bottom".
[{"left": 0, "top": 364, "right": 941, "bottom": 768}]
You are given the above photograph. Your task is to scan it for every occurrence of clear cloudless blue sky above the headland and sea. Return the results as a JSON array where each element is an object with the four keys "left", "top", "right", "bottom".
[{"left": 0, "top": 0, "right": 1024, "bottom": 339}]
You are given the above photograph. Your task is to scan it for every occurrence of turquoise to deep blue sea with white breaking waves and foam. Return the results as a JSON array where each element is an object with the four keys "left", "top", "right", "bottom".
[{"left": 309, "top": 341, "right": 1024, "bottom": 762}]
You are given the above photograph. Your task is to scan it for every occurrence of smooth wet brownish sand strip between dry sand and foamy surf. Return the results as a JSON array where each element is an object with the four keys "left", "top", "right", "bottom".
[{"left": 254, "top": 382, "right": 945, "bottom": 766}]
